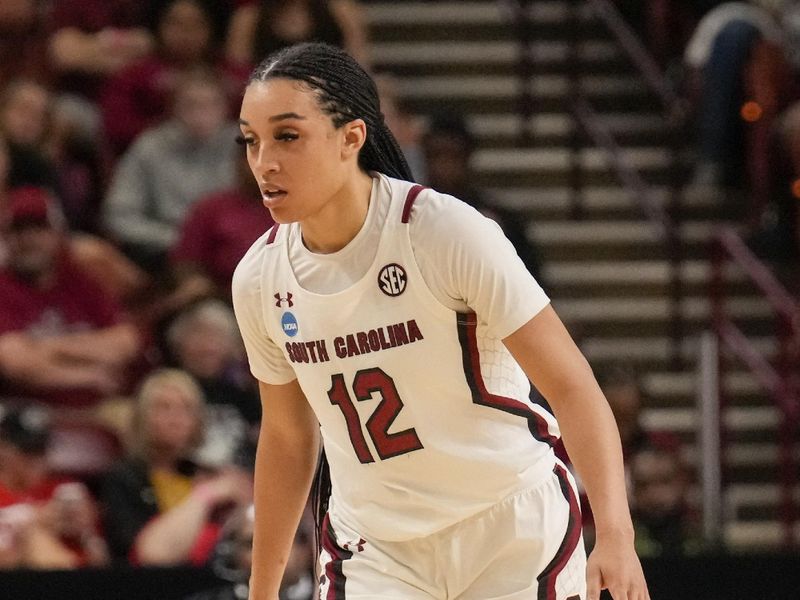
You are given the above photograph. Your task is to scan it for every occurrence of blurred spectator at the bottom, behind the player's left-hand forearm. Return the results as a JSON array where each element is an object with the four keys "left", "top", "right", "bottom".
[{"left": 187, "top": 505, "right": 317, "bottom": 600}]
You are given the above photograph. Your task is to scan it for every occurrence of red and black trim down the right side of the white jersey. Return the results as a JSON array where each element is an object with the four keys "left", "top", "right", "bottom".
[{"left": 456, "top": 313, "right": 558, "bottom": 447}]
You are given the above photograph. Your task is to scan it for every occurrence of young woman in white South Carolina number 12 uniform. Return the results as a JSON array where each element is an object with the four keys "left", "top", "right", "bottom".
[{"left": 233, "top": 44, "right": 648, "bottom": 600}]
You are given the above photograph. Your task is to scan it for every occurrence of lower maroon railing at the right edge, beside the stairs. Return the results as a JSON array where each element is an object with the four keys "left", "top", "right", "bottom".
[{"left": 710, "top": 228, "right": 800, "bottom": 547}]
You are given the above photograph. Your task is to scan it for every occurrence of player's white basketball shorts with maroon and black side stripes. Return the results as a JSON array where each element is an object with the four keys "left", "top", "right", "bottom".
[{"left": 320, "top": 464, "right": 586, "bottom": 600}]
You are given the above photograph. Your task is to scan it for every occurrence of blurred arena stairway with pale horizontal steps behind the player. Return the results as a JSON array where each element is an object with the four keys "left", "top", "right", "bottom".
[{"left": 365, "top": 0, "right": 800, "bottom": 550}]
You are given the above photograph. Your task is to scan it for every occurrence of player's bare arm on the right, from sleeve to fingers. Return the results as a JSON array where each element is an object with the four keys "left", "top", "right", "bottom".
[{"left": 503, "top": 305, "right": 650, "bottom": 600}]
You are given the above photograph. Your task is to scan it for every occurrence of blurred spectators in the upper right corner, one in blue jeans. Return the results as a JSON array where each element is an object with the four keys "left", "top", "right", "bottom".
[{"left": 616, "top": 0, "right": 800, "bottom": 265}]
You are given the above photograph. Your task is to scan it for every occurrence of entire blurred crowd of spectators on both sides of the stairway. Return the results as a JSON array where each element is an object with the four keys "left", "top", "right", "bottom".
[{"left": 0, "top": 0, "right": 788, "bottom": 600}]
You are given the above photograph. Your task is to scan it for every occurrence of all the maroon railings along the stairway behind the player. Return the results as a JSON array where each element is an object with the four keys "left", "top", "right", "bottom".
[{"left": 502, "top": 0, "right": 800, "bottom": 544}]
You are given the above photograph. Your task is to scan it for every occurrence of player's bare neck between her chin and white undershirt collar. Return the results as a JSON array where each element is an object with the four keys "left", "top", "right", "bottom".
[{"left": 300, "top": 171, "right": 372, "bottom": 254}]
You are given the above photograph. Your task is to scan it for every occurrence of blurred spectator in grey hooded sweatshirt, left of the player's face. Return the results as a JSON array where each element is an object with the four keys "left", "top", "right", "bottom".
[{"left": 105, "top": 69, "right": 238, "bottom": 272}]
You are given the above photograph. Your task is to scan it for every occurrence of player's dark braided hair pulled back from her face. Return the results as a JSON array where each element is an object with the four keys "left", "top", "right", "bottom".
[{"left": 248, "top": 42, "right": 413, "bottom": 181}]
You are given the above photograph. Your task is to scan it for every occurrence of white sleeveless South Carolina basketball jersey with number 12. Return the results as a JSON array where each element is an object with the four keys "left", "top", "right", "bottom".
[{"left": 244, "top": 179, "right": 559, "bottom": 541}]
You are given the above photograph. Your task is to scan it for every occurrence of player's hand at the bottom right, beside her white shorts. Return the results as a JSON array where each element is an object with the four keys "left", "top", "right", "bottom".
[{"left": 586, "top": 533, "right": 650, "bottom": 600}]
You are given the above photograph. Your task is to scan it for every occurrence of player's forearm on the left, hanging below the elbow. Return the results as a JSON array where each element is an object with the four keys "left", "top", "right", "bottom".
[{"left": 250, "top": 426, "right": 319, "bottom": 600}]
